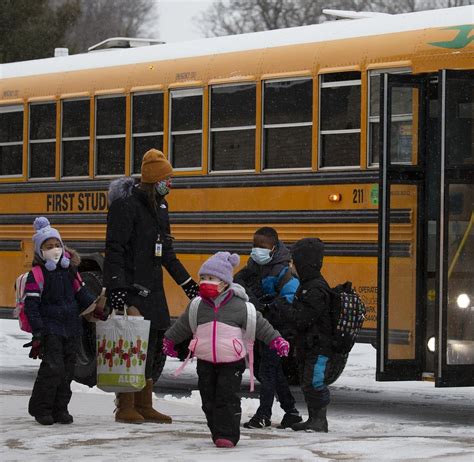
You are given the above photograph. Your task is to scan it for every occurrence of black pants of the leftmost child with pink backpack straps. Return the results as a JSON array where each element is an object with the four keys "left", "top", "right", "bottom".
[{"left": 28, "top": 334, "right": 78, "bottom": 417}]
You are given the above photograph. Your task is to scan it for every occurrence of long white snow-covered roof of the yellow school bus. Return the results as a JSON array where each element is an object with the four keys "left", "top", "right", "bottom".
[{"left": 0, "top": 6, "right": 474, "bottom": 79}]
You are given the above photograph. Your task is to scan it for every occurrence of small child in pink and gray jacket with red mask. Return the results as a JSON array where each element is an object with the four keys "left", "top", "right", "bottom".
[{"left": 163, "top": 252, "right": 289, "bottom": 448}]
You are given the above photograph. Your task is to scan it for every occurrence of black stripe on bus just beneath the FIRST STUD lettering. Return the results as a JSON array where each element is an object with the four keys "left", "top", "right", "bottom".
[{"left": 0, "top": 209, "right": 410, "bottom": 225}]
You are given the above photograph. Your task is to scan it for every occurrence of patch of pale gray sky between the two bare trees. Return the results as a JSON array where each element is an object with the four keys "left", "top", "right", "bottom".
[{"left": 157, "top": 0, "right": 216, "bottom": 42}]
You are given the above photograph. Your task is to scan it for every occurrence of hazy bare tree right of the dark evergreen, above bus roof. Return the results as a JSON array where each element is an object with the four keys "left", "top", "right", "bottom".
[{"left": 50, "top": 0, "right": 158, "bottom": 53}]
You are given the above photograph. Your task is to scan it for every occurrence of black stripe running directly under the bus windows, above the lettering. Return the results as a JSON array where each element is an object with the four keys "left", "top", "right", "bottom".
[{"left": 0, "top": 170, "right": 379, "bottom": 194}]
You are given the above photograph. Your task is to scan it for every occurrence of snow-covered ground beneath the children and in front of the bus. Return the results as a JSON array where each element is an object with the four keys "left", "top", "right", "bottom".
[{"left": 0, "top": 320, "right": 474, "bottom": 462}]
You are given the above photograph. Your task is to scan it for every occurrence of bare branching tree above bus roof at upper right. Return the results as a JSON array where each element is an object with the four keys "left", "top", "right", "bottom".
[{"left": 195, "top": 0, "right": 472, "bottom": 37}]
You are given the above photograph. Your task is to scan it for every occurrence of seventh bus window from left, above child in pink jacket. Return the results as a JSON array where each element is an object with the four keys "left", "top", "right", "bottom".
[{"left": 210, "top": 84, "right": 257, "bottom": 171}]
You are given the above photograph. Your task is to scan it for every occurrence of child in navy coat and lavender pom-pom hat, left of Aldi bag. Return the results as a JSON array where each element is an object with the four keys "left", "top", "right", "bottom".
[{"left": 25, "top": 217, "right": 95, "bottom": 425}]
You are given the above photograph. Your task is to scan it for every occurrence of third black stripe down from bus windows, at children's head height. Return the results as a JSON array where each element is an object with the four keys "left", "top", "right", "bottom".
[{"left": 67, "top": 241, "right": 410, "bottom": 257}]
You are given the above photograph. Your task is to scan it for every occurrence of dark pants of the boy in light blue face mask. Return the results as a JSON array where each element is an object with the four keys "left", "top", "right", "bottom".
[{"left": 255, "top": 344, "right": 295, "bottom": 419}]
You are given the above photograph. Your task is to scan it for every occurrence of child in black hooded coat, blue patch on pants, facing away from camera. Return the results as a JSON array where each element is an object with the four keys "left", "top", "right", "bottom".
[{"left": 291, "top": 238, "right": 332, "bottom": 432}]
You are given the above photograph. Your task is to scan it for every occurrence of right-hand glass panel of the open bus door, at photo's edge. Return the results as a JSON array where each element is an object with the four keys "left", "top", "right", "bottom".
[{"left": 434, "top": 70, "right": 474, "bottom": 386}]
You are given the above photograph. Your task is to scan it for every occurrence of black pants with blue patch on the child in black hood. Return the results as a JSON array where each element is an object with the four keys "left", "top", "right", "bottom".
[{"left": 300, "top": 352, "right": 331, "bottom": 411}]
